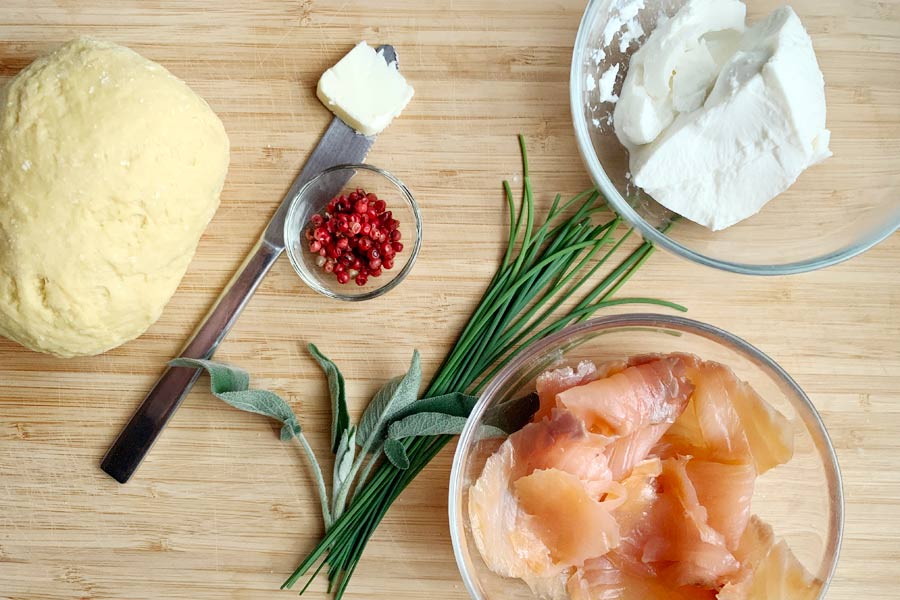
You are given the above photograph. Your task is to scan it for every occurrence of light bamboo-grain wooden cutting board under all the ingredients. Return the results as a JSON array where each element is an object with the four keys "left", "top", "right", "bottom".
[{"left": 0, "top": 0, "right": 900, "bottom": 600}]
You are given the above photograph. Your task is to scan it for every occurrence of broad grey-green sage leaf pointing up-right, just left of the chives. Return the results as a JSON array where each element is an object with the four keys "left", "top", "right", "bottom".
[{"left": 356, "top": 350, "right": 422, "bottom": 452}]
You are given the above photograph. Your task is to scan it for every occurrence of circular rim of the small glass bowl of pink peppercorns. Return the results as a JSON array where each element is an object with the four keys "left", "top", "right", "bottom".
[{"left": 284, "top": 163, "right": 422, "bottom": 302}]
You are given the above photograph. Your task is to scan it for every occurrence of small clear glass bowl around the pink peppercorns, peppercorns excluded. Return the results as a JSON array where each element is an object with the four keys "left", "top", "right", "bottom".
[{"left": 284, "top": 164, "right": 422, "bottom": 302}]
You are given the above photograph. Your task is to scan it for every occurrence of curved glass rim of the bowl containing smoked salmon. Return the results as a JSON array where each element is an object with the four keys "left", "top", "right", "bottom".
[{"left": 447, "top": 313, "right": 844, "bottom": 600}]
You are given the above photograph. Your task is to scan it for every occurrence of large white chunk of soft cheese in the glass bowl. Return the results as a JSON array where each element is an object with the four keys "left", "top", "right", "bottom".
[{"left": 614, "top": 0, "right": 831, "bottom": 230}]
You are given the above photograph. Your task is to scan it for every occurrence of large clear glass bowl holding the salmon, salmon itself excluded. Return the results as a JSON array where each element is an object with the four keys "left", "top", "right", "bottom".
[{"left": 449, "top": 314, "right": 844, "bottom": 600}]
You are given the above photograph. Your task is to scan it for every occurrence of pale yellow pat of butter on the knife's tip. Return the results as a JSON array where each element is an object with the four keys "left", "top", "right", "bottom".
[{"left": 316, "top": 42, "right": 413, "bottom": 135}]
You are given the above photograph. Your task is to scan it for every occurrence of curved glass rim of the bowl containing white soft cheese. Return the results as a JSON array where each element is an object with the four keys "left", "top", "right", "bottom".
[{"left": 569, "top": 0, "right": 900, "bottom": 275}]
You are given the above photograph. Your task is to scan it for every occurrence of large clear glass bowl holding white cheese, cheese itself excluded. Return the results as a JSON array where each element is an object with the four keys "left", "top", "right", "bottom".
[{"left": 570, "top": 0, "right": 900, "bottom": 275}]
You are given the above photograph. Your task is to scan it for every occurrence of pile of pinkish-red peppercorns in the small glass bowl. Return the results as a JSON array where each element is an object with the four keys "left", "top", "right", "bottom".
[{"left": 306, "top": 189, "right": 403, "bottom": 286}]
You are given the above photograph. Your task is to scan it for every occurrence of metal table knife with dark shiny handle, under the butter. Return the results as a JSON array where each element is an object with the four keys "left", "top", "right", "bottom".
[{"left": 100, "top": 45, "right": 397, "bottom": 483}]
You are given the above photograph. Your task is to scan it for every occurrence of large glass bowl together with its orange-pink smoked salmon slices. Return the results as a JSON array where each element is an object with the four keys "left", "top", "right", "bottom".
[{"left": 449, "top": 314, "right": 843, "bottom": 600}]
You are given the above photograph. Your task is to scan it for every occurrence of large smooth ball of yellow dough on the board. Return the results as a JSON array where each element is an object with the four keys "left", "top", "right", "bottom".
[{"left": 0, "top": 38, "right": 229, "bottom": 356}]
